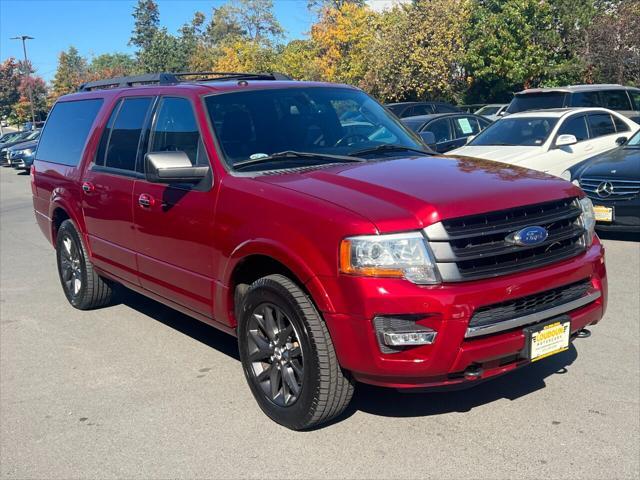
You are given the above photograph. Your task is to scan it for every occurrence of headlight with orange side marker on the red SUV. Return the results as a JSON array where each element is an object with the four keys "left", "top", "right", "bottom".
[{"left": 340, "top": 232, "right": 439, "bottom": 284}]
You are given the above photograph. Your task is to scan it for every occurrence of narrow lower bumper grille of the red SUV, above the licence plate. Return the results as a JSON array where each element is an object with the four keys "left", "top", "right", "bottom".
[{"left": 469, "top": 280, "right": 591, "bottom": 327}]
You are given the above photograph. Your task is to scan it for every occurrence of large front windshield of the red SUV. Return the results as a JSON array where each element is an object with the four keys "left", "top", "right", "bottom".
[{"left": 205, "top": 87, "right": 425, "bottom": 170}]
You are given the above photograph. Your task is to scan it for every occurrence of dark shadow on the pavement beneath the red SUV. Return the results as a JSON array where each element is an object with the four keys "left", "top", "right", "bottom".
[{"left": 112, "top": 288, "right": 580, "bottom": 428}]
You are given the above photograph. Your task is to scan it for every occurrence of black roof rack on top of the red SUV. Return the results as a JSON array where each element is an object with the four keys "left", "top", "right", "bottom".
[{"left": 78, "top": 72, "right": 293, "bottom": 92}]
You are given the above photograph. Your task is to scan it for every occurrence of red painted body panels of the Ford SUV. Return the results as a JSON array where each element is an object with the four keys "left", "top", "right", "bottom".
[{"left": 33, "top": 81, "right": 607, "bottom": 388}]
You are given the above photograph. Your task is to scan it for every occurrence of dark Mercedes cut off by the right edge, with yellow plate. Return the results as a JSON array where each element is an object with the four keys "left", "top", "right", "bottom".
[{"left": 563, "top": 127, "right": 640, "bottom": 232}]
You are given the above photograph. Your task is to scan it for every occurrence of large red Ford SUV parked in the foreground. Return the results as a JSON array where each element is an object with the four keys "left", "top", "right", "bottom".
[{"left": 31, "top": 74, "right": 607, "bottom": 429}]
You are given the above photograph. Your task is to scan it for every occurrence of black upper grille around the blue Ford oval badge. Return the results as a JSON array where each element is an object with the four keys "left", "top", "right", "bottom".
[{"left": 425, "top": 198, "right": 586, "bottom": 282}]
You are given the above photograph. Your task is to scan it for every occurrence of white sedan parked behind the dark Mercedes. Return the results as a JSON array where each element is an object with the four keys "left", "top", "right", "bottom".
[{"left": 447, "top": 108, "right": 640, "bottom": 176}]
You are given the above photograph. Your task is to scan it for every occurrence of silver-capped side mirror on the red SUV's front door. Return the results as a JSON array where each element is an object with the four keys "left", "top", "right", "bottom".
[{"left": 144, "top": 152, "right": 209, "bottom": 183}]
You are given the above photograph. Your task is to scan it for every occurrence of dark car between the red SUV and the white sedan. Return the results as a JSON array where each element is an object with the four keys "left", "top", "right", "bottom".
[{"left": 402, "top": 113, "right": 491, "bottom": 153}]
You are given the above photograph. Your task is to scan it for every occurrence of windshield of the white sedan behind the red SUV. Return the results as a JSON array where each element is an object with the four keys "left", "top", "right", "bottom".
[{"left": 469, "top": 117, "right": 558, "bottom": 147}]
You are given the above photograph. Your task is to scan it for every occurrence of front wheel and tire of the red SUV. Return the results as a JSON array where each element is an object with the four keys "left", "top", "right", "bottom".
[{"left": 238, "top": 275, "right": 354, "bottom": 430}]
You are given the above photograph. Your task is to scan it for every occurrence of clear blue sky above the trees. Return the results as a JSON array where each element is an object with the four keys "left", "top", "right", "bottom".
[{"left": 0, "top": 0, "right": 313, "bottom": 81}]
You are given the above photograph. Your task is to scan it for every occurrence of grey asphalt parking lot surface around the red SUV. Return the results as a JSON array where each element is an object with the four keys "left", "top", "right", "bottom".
[{"left": 0, "top": 168, "right": 640, "bottom": 479}]
